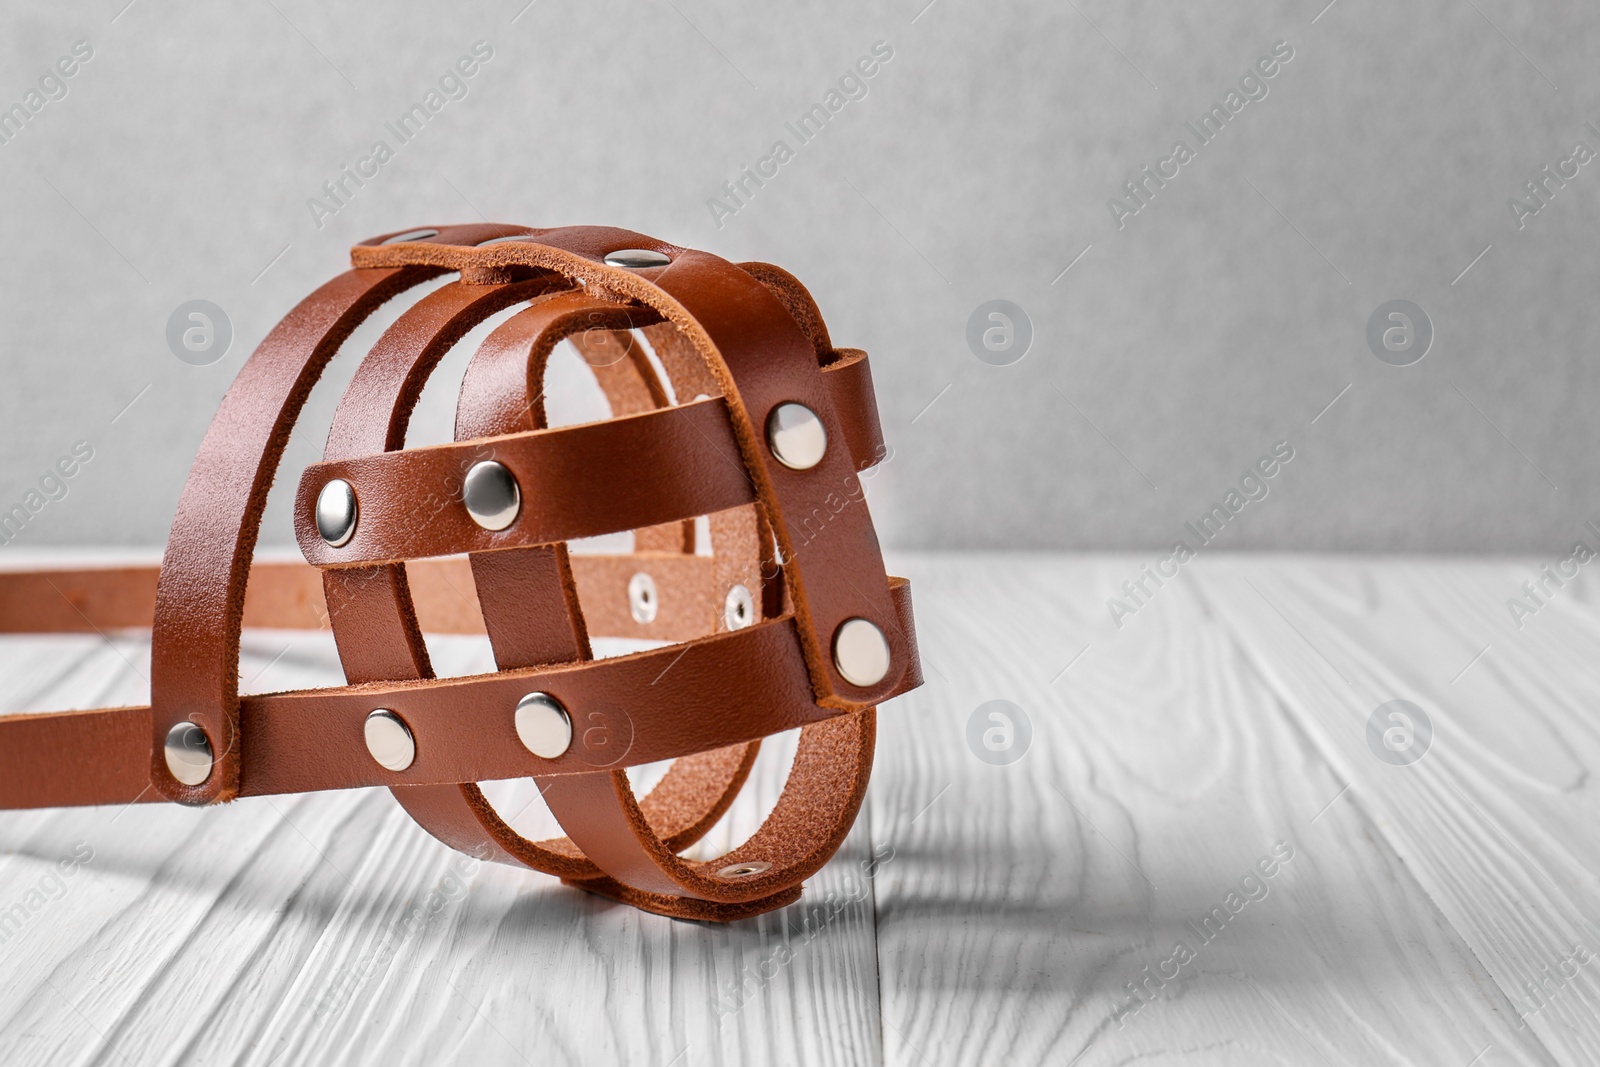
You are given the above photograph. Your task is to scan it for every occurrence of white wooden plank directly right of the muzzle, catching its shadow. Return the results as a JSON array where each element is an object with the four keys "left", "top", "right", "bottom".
[{"left": 874, "top": 557, "right": 1554, "bottom": 1065}]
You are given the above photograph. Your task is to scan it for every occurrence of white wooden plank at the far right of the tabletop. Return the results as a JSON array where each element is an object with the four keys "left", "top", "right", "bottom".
[{"left": 1202, "top": 560, "right": 1600, "bottom": 1064}]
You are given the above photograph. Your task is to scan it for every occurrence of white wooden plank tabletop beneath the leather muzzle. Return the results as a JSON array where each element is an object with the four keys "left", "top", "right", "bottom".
[{"left": 0, "top": 555, "right": 1600, "bottom": 1067}]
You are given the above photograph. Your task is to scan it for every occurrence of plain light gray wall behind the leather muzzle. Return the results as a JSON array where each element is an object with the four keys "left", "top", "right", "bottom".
[{"left": 0, "top": 0, "right": 1600, "bottom": 553}]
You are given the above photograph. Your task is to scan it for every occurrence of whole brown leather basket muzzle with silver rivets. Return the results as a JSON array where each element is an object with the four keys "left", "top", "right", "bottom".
[{"left": 0, "top": 224, "right": 920, "bottom": 920}]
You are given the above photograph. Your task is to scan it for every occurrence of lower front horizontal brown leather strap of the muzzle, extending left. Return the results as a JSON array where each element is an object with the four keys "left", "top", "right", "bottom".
[{"left": 0, "top": 579, "right": 922, "bottom": 808}]
